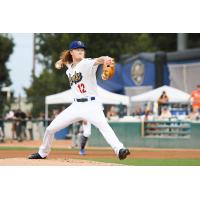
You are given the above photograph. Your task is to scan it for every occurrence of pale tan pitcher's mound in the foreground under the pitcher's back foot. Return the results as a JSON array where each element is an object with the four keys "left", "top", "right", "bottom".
[{"left": 0, "top": 158, "right": 122, "bottom": 166}]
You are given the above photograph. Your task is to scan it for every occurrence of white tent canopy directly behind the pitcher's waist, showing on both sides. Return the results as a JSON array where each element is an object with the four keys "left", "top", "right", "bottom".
[{"left": 45, "top": 86, "right": 129, "bottom": 105}]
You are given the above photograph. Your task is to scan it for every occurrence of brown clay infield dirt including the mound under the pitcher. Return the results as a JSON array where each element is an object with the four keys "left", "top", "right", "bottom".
[{"left": 0, "top": 141, "right": 200, "bottom": 166}]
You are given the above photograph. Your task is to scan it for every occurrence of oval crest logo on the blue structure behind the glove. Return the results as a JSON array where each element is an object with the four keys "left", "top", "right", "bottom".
[{"left": 131, "top": 60, "right": 144, "bottom": 85}]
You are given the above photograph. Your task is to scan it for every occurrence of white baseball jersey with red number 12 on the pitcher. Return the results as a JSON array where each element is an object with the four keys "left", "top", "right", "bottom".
[{"left": 66, "top": 58, "right": 98, "bottom": 98}]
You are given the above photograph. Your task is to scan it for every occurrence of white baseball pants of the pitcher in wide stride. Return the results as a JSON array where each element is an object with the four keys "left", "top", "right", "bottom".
[{"left": 38, "top": 100, "right": 124, "bottom": 157}]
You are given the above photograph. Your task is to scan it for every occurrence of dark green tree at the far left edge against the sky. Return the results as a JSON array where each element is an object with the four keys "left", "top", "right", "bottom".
[{"left": 0, "top": 34, "right": 14, "bottom": 115}]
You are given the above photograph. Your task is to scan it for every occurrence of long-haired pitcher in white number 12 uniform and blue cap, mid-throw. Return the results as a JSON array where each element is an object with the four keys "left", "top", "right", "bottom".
[{"left": 29, "top": 41, "right": 130, "bottom": 160}]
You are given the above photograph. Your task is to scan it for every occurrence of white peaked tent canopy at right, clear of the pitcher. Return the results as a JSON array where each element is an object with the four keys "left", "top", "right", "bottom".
[{"left": 131, "top": 85, "right": 190, "bottom": 102}]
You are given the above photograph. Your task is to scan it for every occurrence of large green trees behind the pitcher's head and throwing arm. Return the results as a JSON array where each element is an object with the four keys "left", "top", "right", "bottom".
[{"left": 25, "top": 33, "right": 173, "bottom": 115}]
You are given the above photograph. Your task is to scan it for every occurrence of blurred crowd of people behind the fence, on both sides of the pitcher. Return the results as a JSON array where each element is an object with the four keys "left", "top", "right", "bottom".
[{"left": 0, "top": 85, "right": 200, "bottom": 142}]
